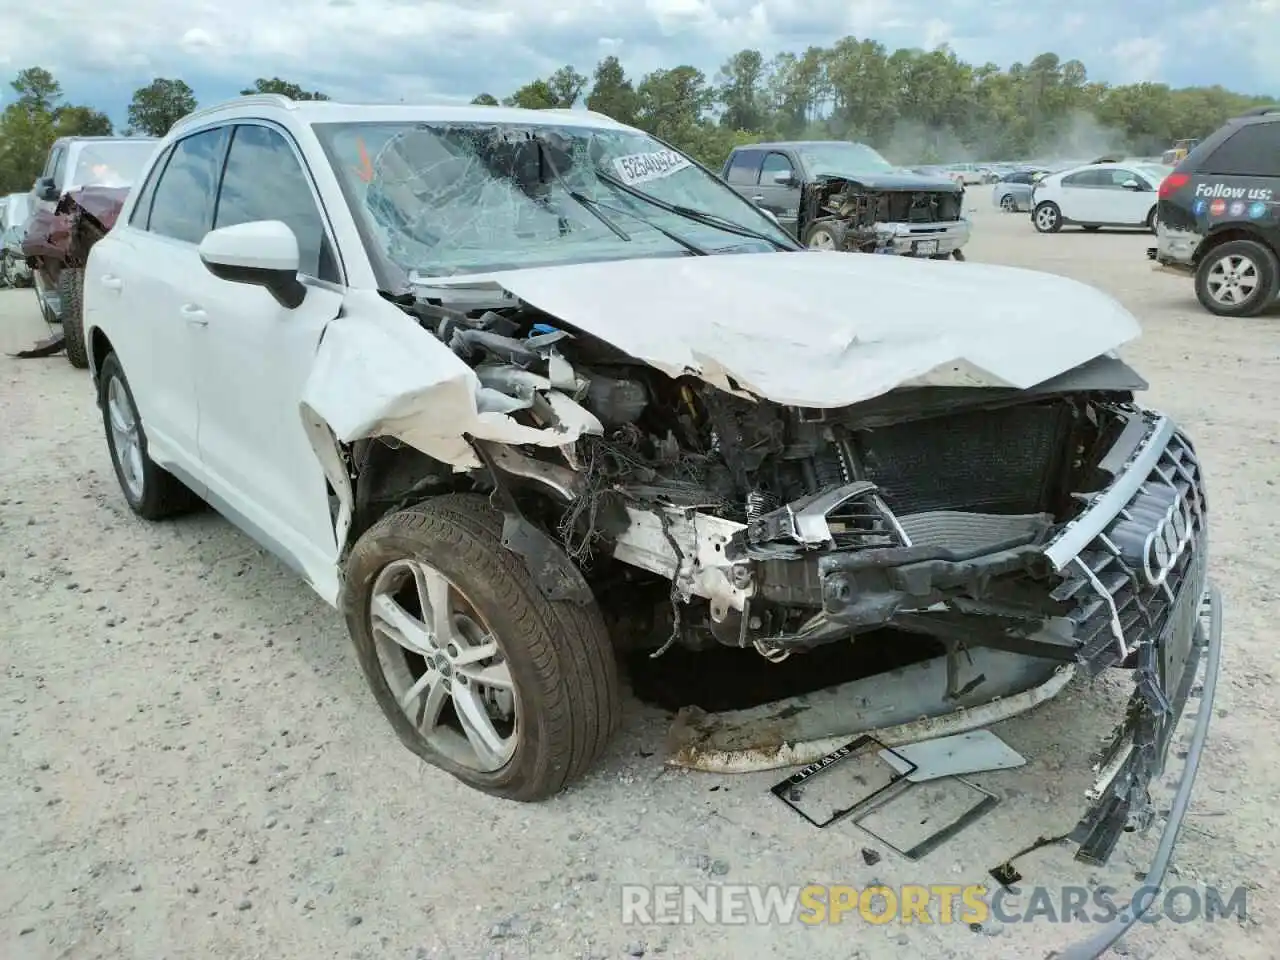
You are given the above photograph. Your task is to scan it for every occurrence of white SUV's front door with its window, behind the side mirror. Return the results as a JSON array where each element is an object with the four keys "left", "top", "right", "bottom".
[{"left": 182, "top": 120, "right": 346, "bottom": 594}]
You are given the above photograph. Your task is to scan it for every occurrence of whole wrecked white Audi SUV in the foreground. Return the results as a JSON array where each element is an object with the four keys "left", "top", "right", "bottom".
[{"left": 86, "top": 97, "right": 1221, "bottom": 947}]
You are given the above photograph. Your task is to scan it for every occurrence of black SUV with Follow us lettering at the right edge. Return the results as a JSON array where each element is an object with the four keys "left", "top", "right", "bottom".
[{"left": 1147, "top": 106, "right": 1280, "bottom": 316}]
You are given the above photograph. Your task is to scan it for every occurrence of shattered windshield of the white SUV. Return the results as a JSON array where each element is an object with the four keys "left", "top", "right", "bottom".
[{"left": 315, "top": 122, "right": 790, "bottom": 278}]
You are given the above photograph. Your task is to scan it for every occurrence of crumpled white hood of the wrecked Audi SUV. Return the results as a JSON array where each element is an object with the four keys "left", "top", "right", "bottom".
[{"left": 421, "top": 251, "right": 1140, "bottom": 408}]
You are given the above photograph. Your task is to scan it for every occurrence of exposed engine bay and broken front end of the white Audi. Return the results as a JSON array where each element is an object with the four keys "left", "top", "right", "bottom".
[{"left": 370, "top": 298, "right": 1172, "bottom": 666}]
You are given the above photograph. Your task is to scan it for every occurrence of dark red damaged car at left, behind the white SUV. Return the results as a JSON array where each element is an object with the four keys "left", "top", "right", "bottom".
[{"left": 19, "top": 137, "right": 156, "bottom": 367}]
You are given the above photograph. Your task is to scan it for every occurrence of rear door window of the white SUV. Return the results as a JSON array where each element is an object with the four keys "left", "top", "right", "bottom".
[{"left": 147, "top": 127, "right": 230, "bottom": 243}]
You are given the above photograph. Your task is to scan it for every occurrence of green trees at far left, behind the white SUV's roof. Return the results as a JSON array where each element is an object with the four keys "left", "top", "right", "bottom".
[{"left": 0, "top": 67, "right": 329, "bottom": 196}]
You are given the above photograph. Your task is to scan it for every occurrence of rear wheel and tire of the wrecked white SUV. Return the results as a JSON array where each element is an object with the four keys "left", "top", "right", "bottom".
[{"left": 97, "top": 353, "right": 200, "bottom": 520}]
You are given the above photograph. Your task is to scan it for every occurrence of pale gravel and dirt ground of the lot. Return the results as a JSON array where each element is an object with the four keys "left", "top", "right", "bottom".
[{"left": 0, "top": 198, "right": 1280, "bottom": 960}]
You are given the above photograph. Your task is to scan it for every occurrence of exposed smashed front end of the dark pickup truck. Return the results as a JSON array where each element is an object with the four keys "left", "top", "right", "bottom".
[{"left": 801, "top": 175, "right": 964, "bottom": 253}]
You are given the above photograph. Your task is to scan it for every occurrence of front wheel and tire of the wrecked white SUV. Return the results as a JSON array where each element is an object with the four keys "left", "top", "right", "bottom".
[{"left": 343, "top": 494, "right": 621, "bottom": 801}]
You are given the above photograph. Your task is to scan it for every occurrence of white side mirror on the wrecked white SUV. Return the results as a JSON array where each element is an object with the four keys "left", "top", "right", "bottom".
[{"left": 200, "top": 220, "right": 307, "bottom": 310}]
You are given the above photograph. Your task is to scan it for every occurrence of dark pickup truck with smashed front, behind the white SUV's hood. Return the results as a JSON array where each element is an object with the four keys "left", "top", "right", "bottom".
[{"left": 721, "top": 141, "right": 969, "bottom": 260}]
